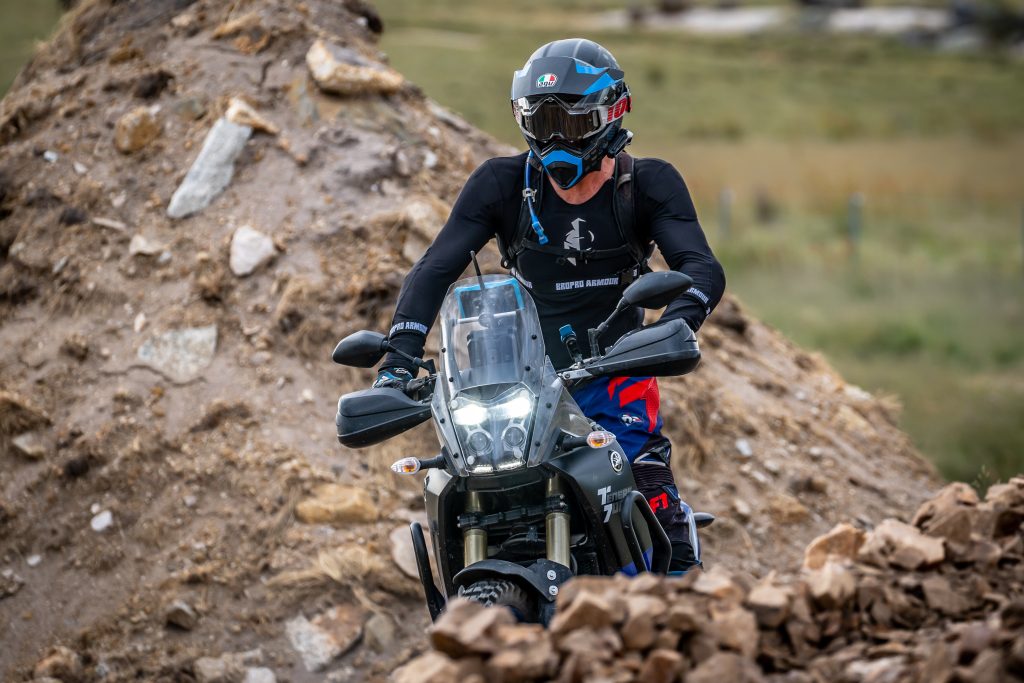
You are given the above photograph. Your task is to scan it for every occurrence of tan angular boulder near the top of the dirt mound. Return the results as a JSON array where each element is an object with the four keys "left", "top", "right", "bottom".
[{"left": 306, "top": 40, "right": 406, "bottom": 95}]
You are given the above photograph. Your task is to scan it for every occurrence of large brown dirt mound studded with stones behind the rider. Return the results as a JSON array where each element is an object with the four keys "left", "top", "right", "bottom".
[{"left": 0, "top": 0, "right": 950, "bottom": 681}]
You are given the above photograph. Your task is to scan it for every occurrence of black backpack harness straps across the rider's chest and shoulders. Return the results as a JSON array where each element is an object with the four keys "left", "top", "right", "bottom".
[{"left": 498, "top": 152, "right": 654, "bottom": 278}]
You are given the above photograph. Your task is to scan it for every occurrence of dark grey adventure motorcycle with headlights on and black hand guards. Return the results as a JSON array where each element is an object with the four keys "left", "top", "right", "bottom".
[{"left": 333, "top": 258, "right": 714, "bottom": 624}]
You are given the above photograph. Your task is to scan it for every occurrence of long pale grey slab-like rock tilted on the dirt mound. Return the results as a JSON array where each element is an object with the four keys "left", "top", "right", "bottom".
[{"left": 167, "top": 118, "right": 253, "bottom": 218}]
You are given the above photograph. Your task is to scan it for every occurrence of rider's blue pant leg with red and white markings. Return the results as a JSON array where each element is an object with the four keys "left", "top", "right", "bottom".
[{"left": 572, "top": 377, "right": 698, "bottom": 569}]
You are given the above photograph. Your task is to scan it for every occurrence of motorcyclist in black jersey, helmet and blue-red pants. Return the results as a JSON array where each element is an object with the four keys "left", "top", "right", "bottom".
[{"left": 374, "top": 38, "right": 725, "bottom": 571}]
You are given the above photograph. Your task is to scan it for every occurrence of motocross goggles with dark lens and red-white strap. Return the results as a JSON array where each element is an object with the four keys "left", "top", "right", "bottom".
[{"left": 512, "top": 90, "right": 631, "bottom": 146}]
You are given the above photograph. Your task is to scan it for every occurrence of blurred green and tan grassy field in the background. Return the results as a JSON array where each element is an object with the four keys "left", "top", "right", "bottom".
[{"left": 368, "top": 0, "right": 1024, "bottom": 482}]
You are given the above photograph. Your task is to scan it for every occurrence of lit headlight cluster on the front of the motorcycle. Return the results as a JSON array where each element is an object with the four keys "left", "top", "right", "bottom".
[{"left": 451, "top": 388, "right": 535, "bottom": 474}]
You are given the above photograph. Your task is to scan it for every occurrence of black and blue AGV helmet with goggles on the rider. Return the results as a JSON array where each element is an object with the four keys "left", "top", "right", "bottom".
[{"left": 512, "top": 38, "right": 632, "bottom": 189}]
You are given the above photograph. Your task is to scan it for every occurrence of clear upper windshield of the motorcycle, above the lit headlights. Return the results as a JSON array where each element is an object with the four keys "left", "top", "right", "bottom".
[{"left": 440, "top": 275, "right": 544, "bottom": 398}]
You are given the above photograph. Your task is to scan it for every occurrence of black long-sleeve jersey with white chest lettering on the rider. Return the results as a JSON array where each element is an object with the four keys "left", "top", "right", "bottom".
[{"left": 384, "top": 153, "right": 725, "bottom": 370}]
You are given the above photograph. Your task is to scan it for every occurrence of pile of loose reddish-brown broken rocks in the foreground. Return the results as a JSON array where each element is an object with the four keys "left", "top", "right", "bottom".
[{"left": 394, "top": 477, "right": 1024, "bottom": 683}]
